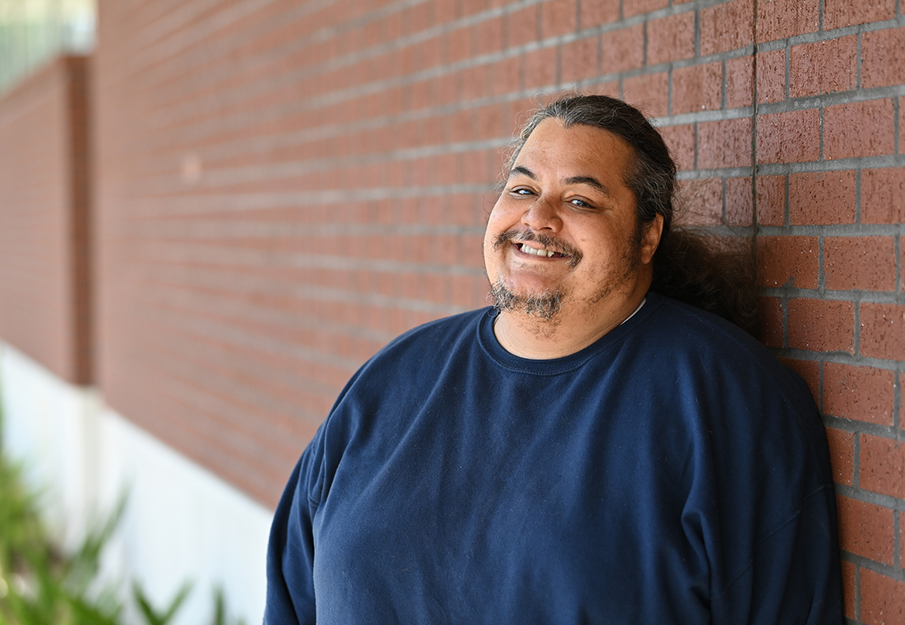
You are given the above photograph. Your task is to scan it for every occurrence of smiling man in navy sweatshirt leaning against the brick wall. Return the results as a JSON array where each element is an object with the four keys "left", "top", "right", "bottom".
[{"left": 264, "top": 96, "right": 842, "bottom": 625}]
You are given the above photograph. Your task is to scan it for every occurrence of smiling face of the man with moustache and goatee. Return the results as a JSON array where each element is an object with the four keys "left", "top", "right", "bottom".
[{"left": 484, "top": 119, "right": 659, "bottom": 318}]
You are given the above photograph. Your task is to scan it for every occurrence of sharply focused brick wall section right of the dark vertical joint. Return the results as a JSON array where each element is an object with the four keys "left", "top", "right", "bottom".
[{"left": 740, "top": 0, "right": 905, "bottom": 623}]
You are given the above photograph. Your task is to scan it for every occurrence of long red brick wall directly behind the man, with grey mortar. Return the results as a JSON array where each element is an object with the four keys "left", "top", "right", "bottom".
[{"left": 86, "top": 0, "right": 905, "bottom": 623}]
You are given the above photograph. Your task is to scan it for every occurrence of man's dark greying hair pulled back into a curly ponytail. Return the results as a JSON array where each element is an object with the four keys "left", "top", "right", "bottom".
[{"left": 506, "top": 95, "right": 760, "bottom": 335}]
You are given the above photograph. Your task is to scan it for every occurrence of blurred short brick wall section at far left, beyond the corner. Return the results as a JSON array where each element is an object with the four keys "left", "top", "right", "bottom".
[{"left": 0, "top": 57, "right": 91, "bottom": 384}]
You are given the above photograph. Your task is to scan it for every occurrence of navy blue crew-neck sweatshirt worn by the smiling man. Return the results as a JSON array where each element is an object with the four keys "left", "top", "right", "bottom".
[{"left": 264, "top": 294, "right": 842, "bottom": 625}]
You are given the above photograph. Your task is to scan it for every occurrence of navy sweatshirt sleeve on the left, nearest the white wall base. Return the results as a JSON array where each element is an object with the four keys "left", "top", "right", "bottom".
[{"left": 264, "top": 432, "right": 322, "bottom": 625}]
